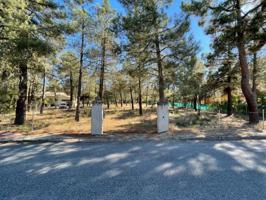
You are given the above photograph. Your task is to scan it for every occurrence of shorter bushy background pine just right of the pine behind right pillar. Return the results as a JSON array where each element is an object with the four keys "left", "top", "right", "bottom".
[{"left": 165, "top": 36, "right": 200, "bottom": 110}]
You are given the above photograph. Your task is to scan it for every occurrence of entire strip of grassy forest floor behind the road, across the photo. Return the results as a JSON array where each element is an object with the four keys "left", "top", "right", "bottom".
[{"left": 0, "top": 105, "right": 266, "bottom": 141}]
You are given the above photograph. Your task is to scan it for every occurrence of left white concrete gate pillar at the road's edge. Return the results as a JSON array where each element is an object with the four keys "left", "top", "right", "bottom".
[{"left": 91, "top": 102, "right": 103, "bottom": 135}]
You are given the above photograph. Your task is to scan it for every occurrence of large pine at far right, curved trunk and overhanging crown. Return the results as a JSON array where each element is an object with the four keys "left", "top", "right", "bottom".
[{"left": 183, "top": 0, "right": 266, "bottom": 124}]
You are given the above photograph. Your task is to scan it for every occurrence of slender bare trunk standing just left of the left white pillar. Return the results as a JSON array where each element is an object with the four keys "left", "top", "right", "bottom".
[{"left": 75, "top": 22, "right": 85, "bottom": 122}]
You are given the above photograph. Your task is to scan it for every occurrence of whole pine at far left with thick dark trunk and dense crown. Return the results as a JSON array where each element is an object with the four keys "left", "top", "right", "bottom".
[{"left": 0, "top": 0, "right": 64, "bottom": 125}]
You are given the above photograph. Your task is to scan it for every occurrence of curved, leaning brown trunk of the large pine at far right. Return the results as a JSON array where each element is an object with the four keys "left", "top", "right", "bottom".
[{"left": 237, "top": 0, "right": 259, "bottom": 124}]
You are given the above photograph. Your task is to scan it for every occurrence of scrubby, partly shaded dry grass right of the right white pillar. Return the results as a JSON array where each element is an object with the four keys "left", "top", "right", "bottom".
[{"left": 170, "top": 110, "right": 264, "bottom": 137}]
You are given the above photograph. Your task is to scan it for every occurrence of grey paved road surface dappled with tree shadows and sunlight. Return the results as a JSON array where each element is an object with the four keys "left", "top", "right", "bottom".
[{"left": 0, "top": 140, "right": 266, "bottom": 200}]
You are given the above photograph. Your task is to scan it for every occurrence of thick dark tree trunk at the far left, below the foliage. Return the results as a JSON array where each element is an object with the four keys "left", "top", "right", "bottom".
[{"left": 14, "top": 63, "right": 28, "bottom": 125}]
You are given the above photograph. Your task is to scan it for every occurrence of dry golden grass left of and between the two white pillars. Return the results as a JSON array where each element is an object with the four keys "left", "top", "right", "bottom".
[{"left": 0, "top": 106, "right": 156, "bottom": 135}]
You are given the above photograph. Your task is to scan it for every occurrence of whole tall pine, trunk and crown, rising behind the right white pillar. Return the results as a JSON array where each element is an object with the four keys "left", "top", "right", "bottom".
[{"left": 120, "top": 0, "right": 189, "bottom": 103}]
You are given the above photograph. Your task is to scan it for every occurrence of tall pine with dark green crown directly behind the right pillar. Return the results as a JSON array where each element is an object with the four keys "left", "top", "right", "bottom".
[{"left": 116, "top": 0, "right": 195, "bottom": 102}]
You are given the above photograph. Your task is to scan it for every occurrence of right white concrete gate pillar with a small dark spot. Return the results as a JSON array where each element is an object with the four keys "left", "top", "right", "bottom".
[{"left": 157, "top": 103, "right": 169, "bottom": 133}]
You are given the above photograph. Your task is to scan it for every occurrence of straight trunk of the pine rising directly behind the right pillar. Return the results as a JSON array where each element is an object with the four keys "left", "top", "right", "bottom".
[{"left": 155, "top": 35, "right": 166, "bottom": 103}]
